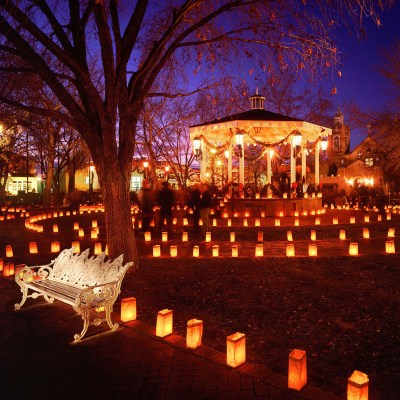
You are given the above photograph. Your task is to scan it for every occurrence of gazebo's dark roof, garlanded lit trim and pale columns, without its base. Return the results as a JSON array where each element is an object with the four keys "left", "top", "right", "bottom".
[{"left": 189, "top": 90, "right": 332, "bottom": 185}]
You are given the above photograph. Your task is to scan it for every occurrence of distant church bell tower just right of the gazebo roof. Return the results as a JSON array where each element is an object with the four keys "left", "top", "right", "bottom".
[{"left": 327, "top": 108, "right": 350, "bottom": 167}]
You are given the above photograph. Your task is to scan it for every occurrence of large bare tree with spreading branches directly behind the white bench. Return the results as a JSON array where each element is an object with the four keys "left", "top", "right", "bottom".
[{"left": 0, "top": 0, "right": 390, "bottom": 260}]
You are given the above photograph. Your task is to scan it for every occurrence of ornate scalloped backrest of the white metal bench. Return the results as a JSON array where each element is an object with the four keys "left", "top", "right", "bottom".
[{"left": 48, "top": 248, "right": 133, "bottom": 289}]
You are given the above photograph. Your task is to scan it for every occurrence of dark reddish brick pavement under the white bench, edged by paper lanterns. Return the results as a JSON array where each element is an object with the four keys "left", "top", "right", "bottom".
[{"left": 0, "top": 277, "right": 337, "bottom": 400}]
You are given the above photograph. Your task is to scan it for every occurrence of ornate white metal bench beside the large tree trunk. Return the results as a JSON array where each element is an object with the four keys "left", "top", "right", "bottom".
[{"left": 14, "top": 248, "right": 133, "bottom": 343}]
